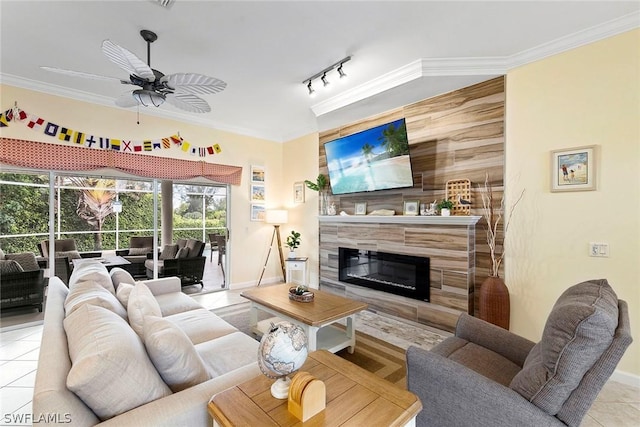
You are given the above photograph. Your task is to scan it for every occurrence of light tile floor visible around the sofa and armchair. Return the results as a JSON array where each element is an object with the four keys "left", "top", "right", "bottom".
[{"left": 0, "top": 291, "right": 640, "bottom": 427}]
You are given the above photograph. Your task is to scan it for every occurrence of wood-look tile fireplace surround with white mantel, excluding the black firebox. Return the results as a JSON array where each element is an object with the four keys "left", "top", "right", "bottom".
[{"left": 319, "top": 215, "right": 481, "bottom": 331}]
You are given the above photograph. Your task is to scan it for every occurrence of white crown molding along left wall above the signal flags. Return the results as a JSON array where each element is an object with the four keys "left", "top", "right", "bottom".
[{"left": 0, "top": 74, "right": 283, "bottom": 142}]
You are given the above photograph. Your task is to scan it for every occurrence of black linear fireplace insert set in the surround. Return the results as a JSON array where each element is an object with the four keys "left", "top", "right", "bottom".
[{"left": 338, "top": 248, "right": 430, "bottom": 301}]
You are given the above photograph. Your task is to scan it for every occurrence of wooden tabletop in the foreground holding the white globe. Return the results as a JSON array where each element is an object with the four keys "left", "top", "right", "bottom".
[{"left": 208, "top": 350, "right": 422, "bottom": 427}]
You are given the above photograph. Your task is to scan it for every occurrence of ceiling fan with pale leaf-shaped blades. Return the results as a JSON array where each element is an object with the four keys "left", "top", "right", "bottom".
[{"left": 40, "top": 30, "right": 227, "bottom": 113}]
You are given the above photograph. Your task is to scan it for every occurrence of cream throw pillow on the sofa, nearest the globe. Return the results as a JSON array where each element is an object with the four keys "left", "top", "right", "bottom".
[{"left": 144, "top": 316, "right": 211, "bottom": 393}]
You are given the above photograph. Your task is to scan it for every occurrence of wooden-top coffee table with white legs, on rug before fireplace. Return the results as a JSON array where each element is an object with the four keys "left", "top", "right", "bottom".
[{"left": 241, "top": 284, "right": 367, "bottom": 353}]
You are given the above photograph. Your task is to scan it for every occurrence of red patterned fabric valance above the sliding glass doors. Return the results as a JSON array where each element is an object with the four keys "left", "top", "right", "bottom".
[{"left": 0, "top": 138, "right": 242, "bottom": 185}]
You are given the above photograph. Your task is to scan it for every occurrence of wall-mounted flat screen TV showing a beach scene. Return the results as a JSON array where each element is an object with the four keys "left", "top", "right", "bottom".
[{"left": 324, "top": 119, "right": 413, "bottom": 194}]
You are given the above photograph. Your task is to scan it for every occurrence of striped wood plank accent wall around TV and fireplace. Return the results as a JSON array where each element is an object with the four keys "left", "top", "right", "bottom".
[{"left": 319, "top": 77, "right": 505, "bottom": 330}]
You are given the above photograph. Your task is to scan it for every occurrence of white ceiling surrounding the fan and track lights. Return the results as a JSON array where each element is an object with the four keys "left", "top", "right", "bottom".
[{"left": 0, "top": 0, "right": 640, "bottom": 141}]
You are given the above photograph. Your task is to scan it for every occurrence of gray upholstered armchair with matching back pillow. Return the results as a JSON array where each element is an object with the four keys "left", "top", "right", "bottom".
[{"left": 407, "top": 280, "right": 632, "bottom": 427}]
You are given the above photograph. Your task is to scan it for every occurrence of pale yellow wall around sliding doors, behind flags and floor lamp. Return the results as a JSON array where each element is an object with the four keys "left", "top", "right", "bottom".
[{"left": 0, "top": 85, "right": 289, "bottom": 287}]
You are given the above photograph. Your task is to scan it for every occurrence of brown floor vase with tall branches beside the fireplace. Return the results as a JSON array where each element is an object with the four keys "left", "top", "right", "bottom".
[{"left": 478, "top": 173, "right": 524, "bottom": 330}]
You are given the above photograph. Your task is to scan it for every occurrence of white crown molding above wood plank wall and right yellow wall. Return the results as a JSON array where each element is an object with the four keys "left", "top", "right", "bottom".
[{"left": 311, "top": 12, "right": 640, "bottom": 117}]
